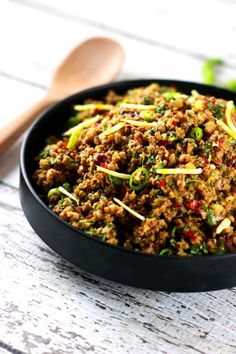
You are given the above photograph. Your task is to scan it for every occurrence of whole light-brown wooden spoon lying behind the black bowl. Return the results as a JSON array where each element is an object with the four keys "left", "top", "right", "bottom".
[{"left": 0, "top": 37, "right": 124, "bottom": 155}]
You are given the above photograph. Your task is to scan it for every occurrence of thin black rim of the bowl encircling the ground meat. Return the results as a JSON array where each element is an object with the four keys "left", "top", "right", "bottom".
[{"left": 20, "top": 78, "right": 236, "bottom": 263}]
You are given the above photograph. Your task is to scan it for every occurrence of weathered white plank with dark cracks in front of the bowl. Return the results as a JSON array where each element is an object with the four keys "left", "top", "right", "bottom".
[{"left": 0, "top": 184, "right": 236, "bottom": 354}]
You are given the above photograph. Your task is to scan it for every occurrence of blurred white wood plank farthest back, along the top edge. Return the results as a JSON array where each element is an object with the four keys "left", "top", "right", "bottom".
[{"left": 7, "top": 0, "right": 236, "bottom": 67}]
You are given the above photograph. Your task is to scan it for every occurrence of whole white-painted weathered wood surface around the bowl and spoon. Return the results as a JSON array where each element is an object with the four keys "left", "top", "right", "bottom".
[{"left": 0, "top": 0, "right": 236, "bottom": 354}]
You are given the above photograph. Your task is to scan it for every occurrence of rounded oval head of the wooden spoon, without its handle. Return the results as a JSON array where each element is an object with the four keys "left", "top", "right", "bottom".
[{"left": 49, "top": 37, "right": 124, "bottom": 99}]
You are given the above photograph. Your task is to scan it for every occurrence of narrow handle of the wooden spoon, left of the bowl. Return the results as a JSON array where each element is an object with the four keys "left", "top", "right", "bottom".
[{"left": 0, "top": 96, "right": 55, "bottom": 156}]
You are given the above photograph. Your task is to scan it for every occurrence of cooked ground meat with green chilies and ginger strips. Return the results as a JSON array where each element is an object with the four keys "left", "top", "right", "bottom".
[{"left": 33, "top": 83, "right": 236, "bottom": 256}]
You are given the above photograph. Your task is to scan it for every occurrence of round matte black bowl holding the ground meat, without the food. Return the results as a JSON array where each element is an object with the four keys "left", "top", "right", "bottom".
[{"left": 20, "top": 79, "right": 236, "bottom": 292}]
